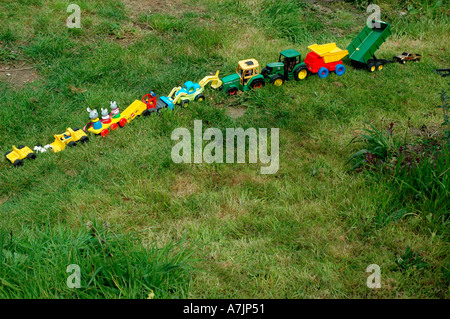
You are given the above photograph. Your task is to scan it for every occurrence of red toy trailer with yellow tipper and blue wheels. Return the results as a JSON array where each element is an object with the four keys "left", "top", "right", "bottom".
[{"left": 304, "top": 43, "right": 348, "bottom": 78}]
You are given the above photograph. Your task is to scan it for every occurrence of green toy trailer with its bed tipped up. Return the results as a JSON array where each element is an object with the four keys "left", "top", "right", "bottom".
[{"left": 347, "top": 21, "right": 393, "bottom": 72}]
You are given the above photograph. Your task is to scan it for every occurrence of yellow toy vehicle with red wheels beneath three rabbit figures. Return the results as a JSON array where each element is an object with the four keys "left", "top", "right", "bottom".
[{"left": 88, "top": 100, "right": 147, "bottom": 137}]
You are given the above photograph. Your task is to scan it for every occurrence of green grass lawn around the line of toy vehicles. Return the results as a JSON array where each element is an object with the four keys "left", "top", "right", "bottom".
[{"left": 0, "top": 0, "right": 450, "bottom": 298}]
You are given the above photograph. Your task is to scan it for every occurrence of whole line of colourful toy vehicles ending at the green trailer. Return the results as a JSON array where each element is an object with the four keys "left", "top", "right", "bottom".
[{"left": 5, "top": 21, "right": 398, "bottom": 166}]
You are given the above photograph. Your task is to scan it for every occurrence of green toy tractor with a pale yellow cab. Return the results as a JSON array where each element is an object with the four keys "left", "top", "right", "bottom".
[{"left": 219, "top": 59, "right": 265, "bottom": 95}]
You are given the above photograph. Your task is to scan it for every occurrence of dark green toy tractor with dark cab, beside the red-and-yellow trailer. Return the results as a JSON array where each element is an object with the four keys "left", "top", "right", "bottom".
[{"left": 261, "top": 49, "right": 308, "bottom": 86}]
